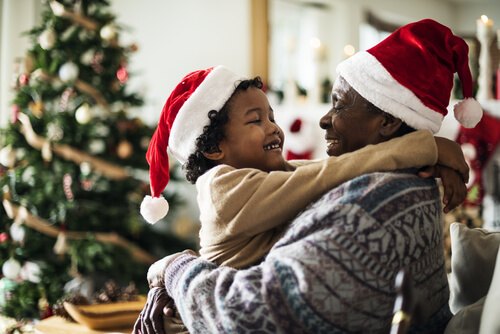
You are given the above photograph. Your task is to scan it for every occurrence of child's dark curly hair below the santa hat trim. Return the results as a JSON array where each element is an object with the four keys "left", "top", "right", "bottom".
[{"left": 182, "top": 77, "right": 264, "bottom": 184}]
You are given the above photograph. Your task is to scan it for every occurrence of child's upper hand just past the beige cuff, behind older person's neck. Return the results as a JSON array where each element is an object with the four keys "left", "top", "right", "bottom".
[{"left": 434, "top": 137, "right": 469, "bottom": 183}]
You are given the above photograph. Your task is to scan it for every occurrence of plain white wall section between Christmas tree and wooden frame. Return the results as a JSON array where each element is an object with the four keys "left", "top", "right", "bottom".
[{"left": 111, "top": 0, "right": 251, "bottom": 124}]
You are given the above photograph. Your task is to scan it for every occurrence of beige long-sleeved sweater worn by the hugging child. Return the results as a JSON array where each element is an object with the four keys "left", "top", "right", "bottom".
[{"left": 196, "top": 130, "right": 438, "bottom": 268}]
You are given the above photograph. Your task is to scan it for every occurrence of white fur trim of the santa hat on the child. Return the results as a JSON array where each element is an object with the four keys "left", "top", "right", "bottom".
[{"left": 168, "top": 66, "right": 246, "bottom": 164}]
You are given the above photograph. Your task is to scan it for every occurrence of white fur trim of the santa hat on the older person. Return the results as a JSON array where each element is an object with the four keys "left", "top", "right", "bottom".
[{"left": 337, "top": 51, "right": 444, "bottom": 133}]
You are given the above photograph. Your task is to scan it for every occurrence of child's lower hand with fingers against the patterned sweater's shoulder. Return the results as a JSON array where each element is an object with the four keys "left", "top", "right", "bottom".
[{"left": 418, "top": 164, "right": 467, "bottom": 213}]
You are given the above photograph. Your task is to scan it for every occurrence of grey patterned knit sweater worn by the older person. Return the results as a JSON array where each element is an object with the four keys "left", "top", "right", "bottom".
[{"left": 165, "top": 170, "right": 451, "bottom": 334}]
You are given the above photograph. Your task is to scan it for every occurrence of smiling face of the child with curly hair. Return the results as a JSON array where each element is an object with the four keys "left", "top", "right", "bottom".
[{"left": 215, "top": 87, "right": 285, "bottom": 172}]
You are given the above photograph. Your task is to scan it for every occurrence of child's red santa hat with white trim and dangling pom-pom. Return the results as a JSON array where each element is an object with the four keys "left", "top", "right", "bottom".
[{"left": 141, "top": 66, "right": 246, "bottom": 224}]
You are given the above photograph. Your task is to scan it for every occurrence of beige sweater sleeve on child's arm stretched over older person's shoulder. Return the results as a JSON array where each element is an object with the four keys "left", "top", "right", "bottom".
[{"left": 201, "top": 130, "right": 437, "bottom": 240}]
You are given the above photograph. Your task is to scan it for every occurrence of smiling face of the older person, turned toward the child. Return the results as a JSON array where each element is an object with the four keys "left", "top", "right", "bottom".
[{"left": 320, "top": 77, "right": 385, "bottom": 156}]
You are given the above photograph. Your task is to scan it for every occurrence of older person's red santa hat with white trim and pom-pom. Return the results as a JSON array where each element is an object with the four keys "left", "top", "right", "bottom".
[{"left": 337, "top": 19, "right": 483, "bottom": 133}]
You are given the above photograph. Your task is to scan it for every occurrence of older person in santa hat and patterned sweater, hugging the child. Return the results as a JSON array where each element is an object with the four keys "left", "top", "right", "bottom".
[{"left": 136, "top": 20, "right": 481, "bottom": 333}]
